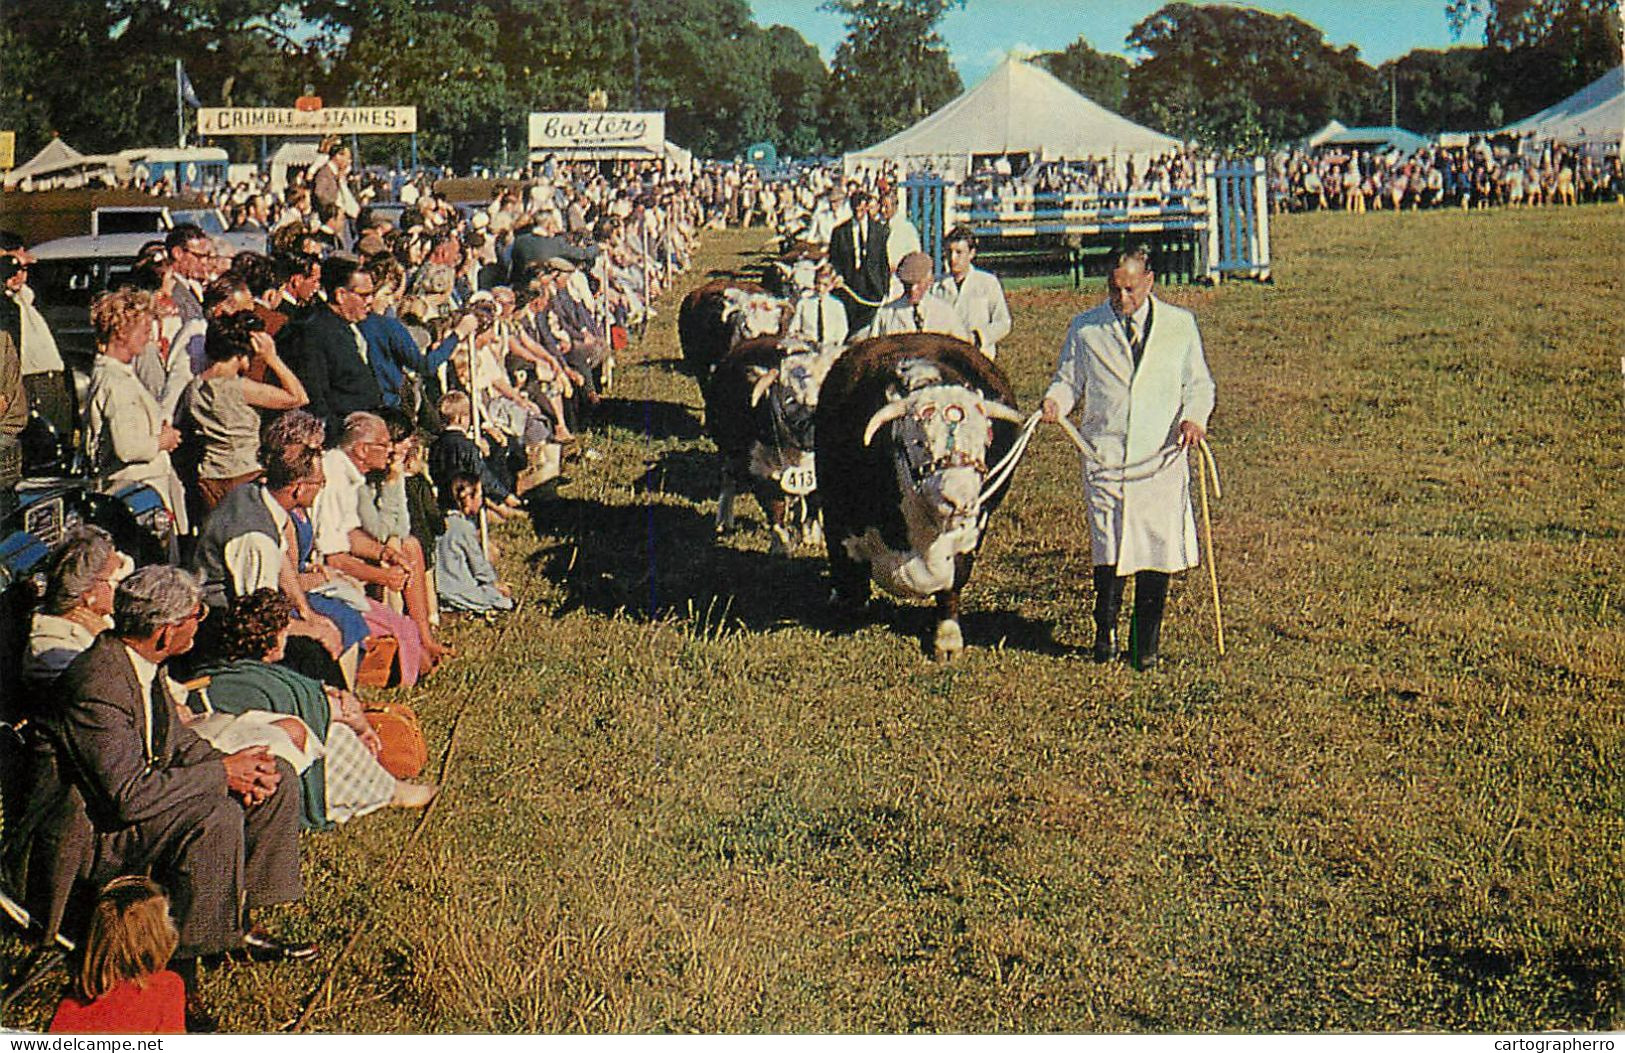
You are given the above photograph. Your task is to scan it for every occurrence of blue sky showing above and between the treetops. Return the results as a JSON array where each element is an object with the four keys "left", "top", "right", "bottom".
[{"left": 749, "top": 0, "right": 1484, "bottom": 88}]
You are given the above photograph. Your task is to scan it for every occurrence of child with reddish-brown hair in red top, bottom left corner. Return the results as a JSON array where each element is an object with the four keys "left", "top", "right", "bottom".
[{"left": 50, "top": 876, "right": 187, "bottom": 1035}]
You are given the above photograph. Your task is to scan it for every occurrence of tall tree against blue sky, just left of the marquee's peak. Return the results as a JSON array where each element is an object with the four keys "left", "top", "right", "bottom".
[{"left": 822, "top": 0, "right": 965, "bottom": 150}]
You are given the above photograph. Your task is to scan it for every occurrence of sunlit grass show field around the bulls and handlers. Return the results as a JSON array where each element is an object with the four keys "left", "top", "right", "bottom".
[{"left": 0, "top": 208, "right": 1625, "bottom": 1032}]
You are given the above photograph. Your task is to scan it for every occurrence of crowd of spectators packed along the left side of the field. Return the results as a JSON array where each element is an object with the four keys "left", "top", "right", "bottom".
[{"left": 0, "top": 141, "right": 698, "bottom": 1027}]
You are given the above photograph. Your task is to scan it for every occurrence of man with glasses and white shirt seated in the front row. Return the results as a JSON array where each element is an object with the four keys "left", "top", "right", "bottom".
[{"left": 312, "top": 413, "right": 452, "bottom": 671}]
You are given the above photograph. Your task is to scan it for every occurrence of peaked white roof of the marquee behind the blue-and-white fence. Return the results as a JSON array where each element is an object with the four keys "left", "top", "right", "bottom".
[{"left": 845, "top": 55, "right": 1180, "bottom": 177}]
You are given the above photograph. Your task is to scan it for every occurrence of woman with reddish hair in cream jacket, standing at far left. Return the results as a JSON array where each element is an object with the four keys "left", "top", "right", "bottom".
[{"left": 85, "top": 289, "right": 189, "bottom": 535}]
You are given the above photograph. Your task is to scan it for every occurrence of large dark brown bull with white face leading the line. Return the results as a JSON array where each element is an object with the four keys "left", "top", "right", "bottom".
[{"left": 814, "top": 333, "right": 1022, "bottom": 661}]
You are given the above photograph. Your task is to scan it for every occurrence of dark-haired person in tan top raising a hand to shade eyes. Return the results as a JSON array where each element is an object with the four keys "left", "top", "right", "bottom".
[{"left": 184, "top": 312, "right": 310, "bottom": 512}]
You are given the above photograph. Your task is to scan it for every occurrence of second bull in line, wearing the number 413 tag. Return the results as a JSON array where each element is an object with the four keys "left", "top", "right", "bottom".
[{"left": 705, "top": 336, "right": 840, "bottom": 554}]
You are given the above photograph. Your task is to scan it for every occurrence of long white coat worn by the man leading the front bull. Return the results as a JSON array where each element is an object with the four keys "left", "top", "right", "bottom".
[{"left": 1045, "top": 297, "right": 1214, "bottom": 577}]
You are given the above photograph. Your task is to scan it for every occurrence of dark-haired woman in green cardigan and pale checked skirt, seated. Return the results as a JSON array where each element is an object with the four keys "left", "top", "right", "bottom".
[{"left": 198, "top": 588, "right": 434, "bottom": 830}]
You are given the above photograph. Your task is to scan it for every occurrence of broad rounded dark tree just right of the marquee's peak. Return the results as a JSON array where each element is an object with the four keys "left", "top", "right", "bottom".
[{"left": 1126, "top": 3, "right": 1372, "bottom": 153}]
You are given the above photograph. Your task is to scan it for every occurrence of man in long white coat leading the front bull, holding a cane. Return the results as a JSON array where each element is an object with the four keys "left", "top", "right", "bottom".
[{"left": 1043, "top": 245, "right": 1214, "bottom": 670}]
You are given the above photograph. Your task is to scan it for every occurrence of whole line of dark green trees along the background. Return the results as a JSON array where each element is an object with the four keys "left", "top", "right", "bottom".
[{"left": 0, "top": 0, "right": 1620, "bottom": 169}]
